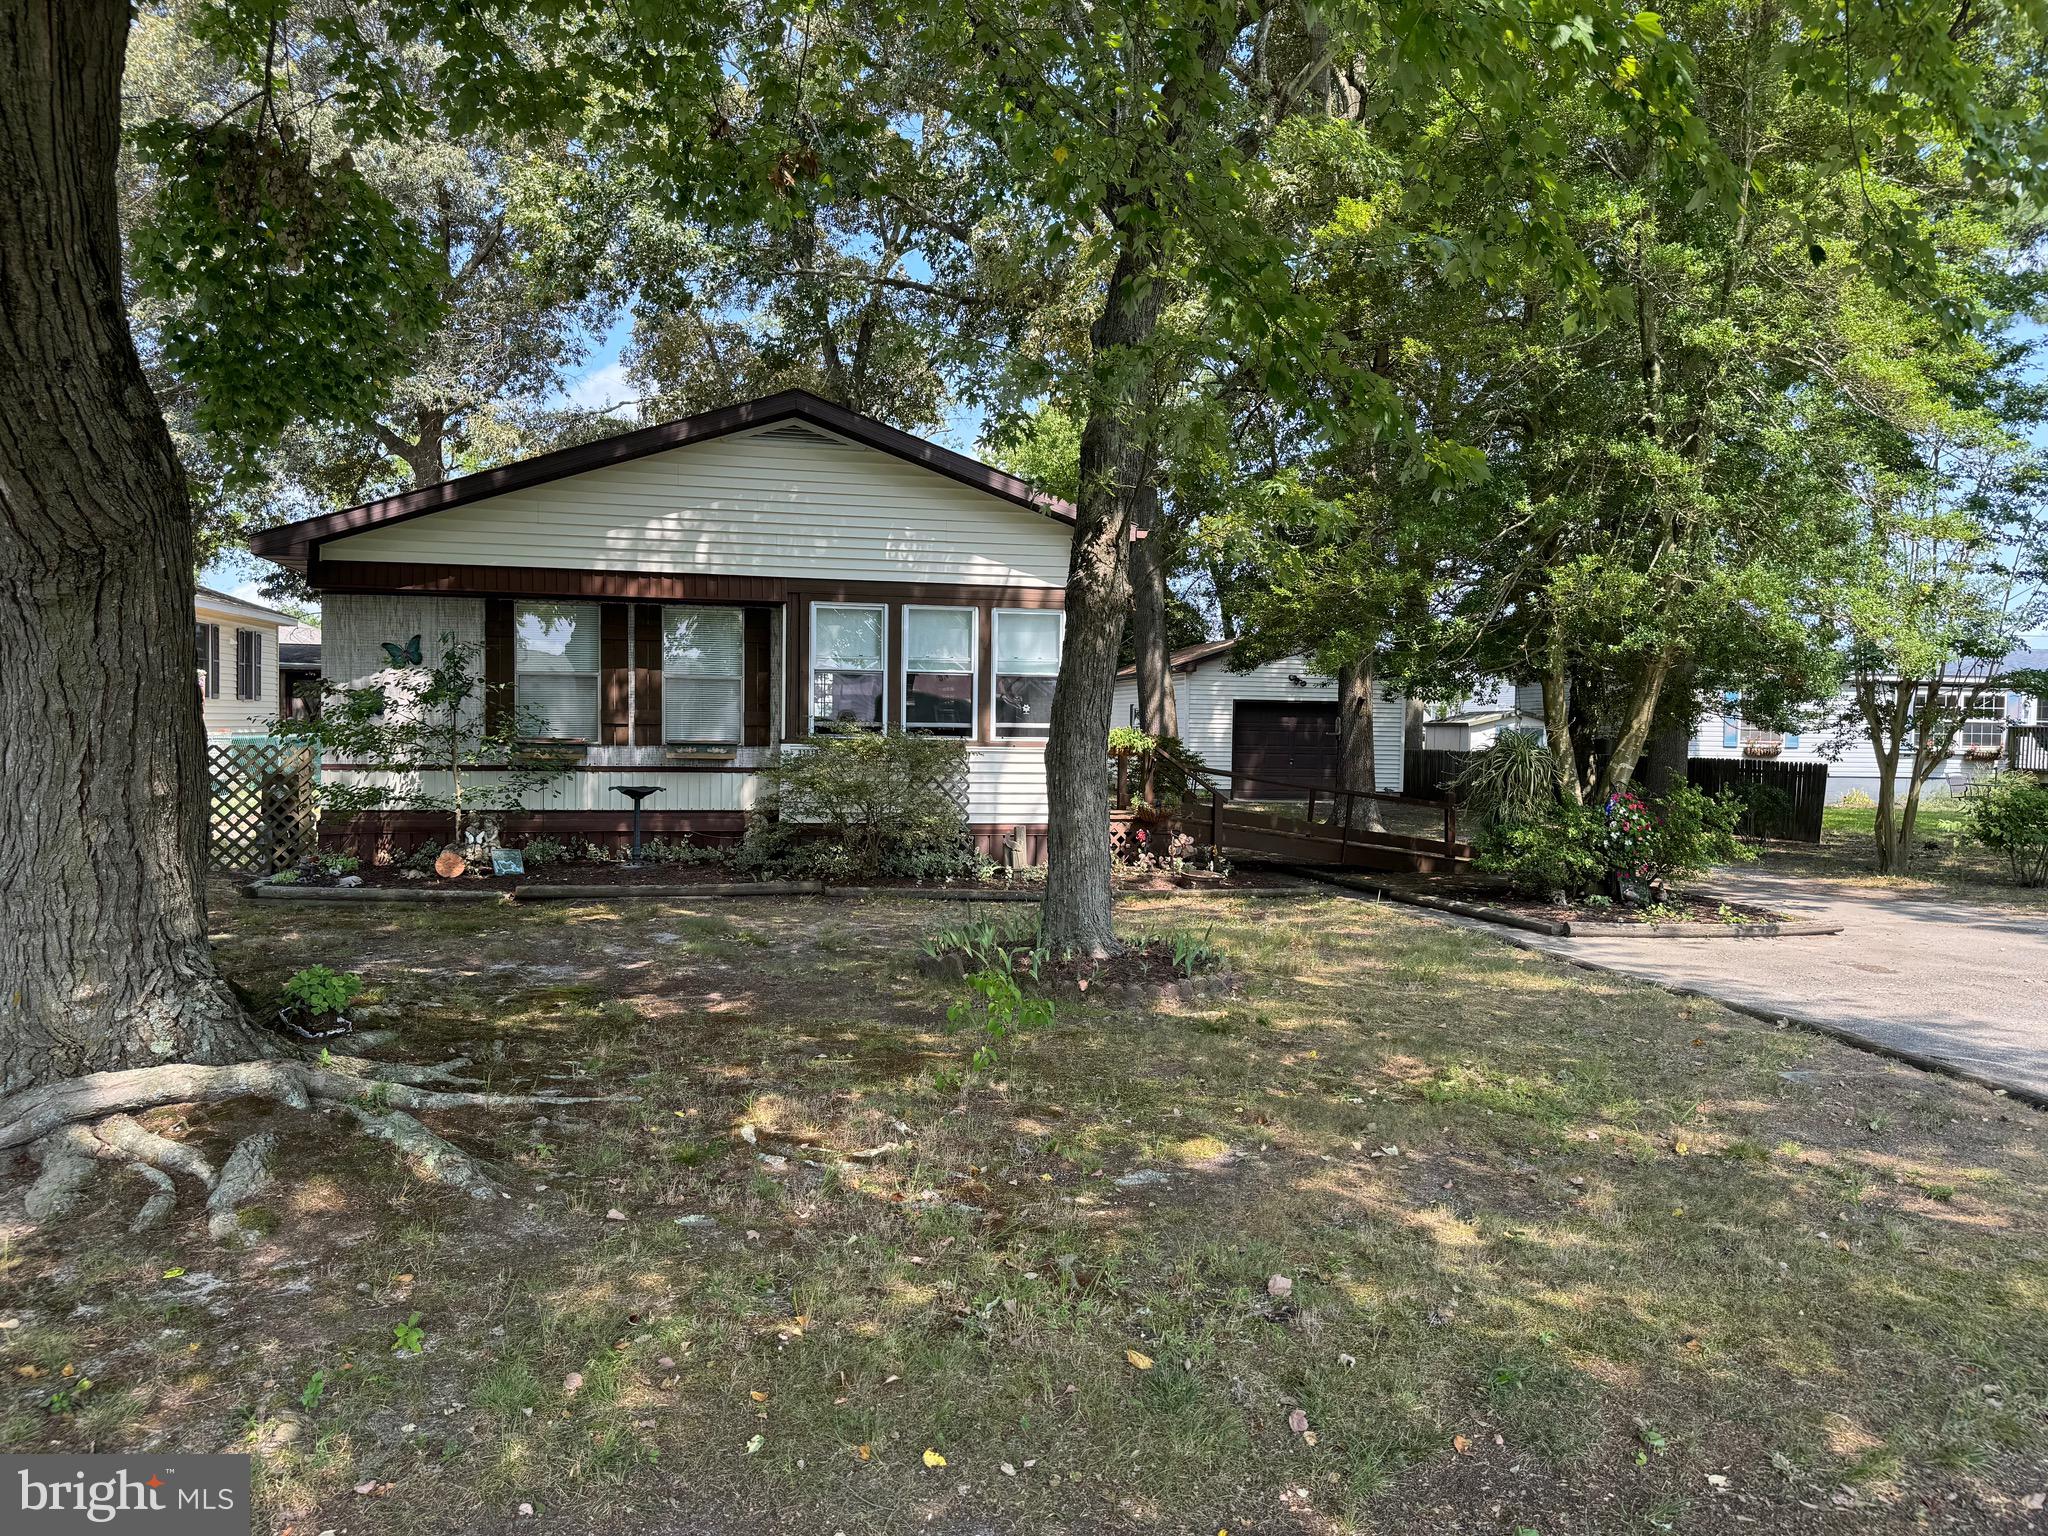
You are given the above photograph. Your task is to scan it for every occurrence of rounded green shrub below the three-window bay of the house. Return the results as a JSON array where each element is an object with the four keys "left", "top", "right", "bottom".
[{"left": 735, "top": 731, "right": 981, "bottom": 881}]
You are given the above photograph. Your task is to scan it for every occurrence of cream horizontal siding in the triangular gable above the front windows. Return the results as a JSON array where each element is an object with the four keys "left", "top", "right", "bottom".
[{"left": 319, "top": 426, "right": 1071, "bottom": 588}]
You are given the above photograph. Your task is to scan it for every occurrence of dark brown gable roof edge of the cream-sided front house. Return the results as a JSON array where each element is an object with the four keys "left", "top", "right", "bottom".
[{"left": 250, "top": 389, "right": 1073, "bottom": 571}]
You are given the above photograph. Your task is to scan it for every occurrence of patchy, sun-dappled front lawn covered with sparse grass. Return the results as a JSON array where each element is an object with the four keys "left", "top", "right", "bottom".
[{"left": 0, "top": 891, "right": 2048, "bottom": 1536}]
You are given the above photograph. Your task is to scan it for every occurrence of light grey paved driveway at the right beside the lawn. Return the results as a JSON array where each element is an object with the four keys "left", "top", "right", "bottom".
[{"left": 1441, "top": 870, "right": 2048, "bottom": 1098}]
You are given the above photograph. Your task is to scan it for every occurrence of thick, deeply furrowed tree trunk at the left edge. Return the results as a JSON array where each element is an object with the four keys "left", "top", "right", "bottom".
[{"left": 0, "top": 0, "right": 262, "bottom": 1094}]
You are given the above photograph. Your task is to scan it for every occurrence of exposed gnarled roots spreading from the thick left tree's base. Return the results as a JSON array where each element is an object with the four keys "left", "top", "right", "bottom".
[{"left": 0, "top": 1055, "right": 631, "bottom": 1243}]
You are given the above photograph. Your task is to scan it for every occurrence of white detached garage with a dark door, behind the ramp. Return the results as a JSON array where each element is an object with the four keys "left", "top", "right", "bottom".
[{"left": 1110, "top": 639, "right": 1407, "bottom": 799}]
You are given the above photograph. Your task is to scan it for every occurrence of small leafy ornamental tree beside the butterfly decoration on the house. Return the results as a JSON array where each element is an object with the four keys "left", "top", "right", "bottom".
[{"left": 279, "top": 635, "right": 563, "bottom": 844}]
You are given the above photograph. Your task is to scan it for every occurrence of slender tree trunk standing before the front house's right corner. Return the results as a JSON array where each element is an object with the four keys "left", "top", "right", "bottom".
[{"left": 1038, "top": 227, "right": 1165, "bottom": 954}]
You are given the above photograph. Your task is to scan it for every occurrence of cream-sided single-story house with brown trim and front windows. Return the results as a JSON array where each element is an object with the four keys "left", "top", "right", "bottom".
[{"left": 250, "top": 391, "right": 1073, "bottom": 858}]
